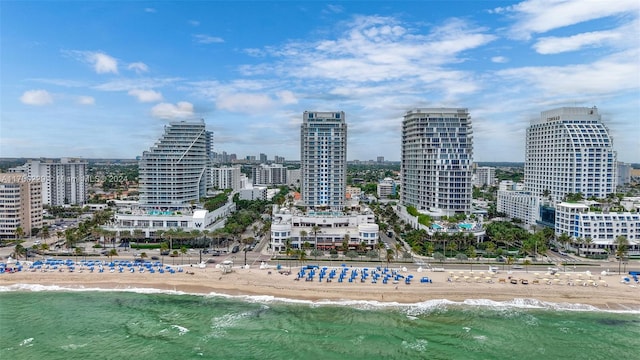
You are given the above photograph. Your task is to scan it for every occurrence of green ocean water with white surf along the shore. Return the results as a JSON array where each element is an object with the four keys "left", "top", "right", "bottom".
[{"left": 0, "top": 285, "right": 640, "bottom": 360}]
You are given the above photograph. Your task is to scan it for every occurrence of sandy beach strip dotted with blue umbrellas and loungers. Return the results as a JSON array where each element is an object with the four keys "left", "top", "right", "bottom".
[{"left": 0, "top": 264, "right": 640, "bottom": 310}]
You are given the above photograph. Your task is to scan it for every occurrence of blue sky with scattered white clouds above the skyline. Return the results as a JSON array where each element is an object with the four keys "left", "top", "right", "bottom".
[{"left": 0, "top": 0, "right": 640, "bottom": 162}]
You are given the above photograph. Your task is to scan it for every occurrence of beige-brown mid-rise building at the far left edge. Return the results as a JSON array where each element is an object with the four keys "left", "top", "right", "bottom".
[{"left": 0, "top": 173, "right": 42, "bottom": 239}]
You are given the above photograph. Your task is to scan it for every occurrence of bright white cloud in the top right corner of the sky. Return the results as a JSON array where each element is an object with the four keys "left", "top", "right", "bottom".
[{"left": 494, "top": 0, "right": 640, "bottom": 39}]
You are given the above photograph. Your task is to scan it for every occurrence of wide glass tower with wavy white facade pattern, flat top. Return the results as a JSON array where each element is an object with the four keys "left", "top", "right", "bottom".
[{"left": 401, "top": 108, "right": 473, "bottom": 215}]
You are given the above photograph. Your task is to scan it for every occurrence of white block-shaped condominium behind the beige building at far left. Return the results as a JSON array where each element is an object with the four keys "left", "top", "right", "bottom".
[{"left": 22, "top": 158, "right": 89, "bottom": 206}]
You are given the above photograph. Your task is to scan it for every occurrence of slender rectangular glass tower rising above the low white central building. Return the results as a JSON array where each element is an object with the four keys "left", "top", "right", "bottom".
[{"left": 300, "top": 111, "right": 347, "bottom": 210}]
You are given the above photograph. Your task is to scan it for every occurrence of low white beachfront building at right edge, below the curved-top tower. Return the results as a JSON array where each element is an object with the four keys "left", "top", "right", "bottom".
[{"left": 555, "top": 202, "right": 640, "bottom": 256}]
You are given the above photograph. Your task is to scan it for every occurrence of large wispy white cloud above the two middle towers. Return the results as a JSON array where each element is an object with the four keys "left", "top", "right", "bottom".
[{"left": 258, "top": 16, "right": 496, "bottom": 83}]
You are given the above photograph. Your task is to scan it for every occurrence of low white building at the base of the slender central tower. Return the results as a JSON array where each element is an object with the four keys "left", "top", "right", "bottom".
[{"left": 269, "top": 205, "right": 379, "bottom": 252}]
